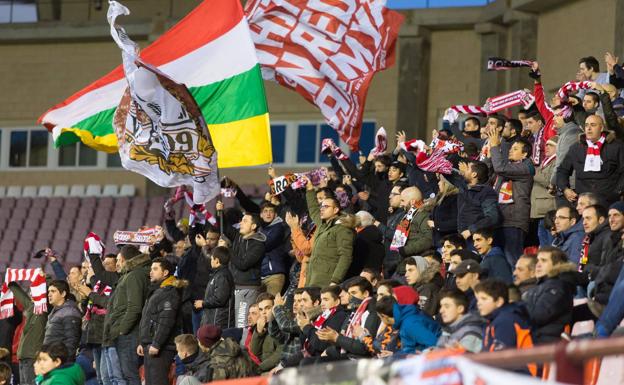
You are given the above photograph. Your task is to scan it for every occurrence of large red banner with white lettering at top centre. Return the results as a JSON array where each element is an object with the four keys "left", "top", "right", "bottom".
[{"left": 245, "top": 0, "right": 403, "bottom": 151}]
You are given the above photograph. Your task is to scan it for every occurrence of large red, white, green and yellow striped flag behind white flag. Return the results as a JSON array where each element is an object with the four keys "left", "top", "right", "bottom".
[{"left": 39, "top": 0, "right": 271, "bottom": 167}]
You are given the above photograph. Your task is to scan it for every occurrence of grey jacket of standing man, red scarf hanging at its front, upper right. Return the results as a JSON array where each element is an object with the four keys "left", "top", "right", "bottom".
[{"left": 490, "top": 146, "right": 535, "bottom": 233}]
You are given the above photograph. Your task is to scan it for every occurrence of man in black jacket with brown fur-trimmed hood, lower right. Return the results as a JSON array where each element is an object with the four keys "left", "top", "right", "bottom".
[{"left": 524, "top": 246, "right": 577, "bottom": 344}]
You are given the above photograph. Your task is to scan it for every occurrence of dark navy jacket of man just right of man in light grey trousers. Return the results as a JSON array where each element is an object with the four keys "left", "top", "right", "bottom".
[{"left": 260, "top": 216, "right": 290, "bottom": 278}]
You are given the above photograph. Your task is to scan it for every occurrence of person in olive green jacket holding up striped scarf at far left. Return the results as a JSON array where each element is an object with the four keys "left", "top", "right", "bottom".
[{"left": 8, "top": 282, "right": 48, "bottom": 385}]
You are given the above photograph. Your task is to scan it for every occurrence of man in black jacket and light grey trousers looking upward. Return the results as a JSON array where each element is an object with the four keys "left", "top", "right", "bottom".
[{"left": 217, "top": 202, "right": 266, "bottom": 328}]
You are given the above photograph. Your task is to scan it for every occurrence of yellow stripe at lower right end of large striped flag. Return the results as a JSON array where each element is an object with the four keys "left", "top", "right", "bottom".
[{"left": 208, "top": 113, "right": 273, "bottom": 168}]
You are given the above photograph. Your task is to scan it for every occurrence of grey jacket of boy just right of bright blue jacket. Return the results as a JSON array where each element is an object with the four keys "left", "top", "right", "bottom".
[{"left": 437, "top": 313, "right": 485, "bottom": 353}]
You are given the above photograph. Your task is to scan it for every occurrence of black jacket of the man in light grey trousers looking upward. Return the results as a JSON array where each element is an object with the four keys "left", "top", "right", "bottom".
[{"left": 225, "top": 226, "right": 266, "bottom": 286}]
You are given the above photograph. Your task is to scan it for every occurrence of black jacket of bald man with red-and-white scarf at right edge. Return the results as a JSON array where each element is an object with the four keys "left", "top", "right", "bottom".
[{"left": 556, "top": 131, "right": 624, "bottom": 205}]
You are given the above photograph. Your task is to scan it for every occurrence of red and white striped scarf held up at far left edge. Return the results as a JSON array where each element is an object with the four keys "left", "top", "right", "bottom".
[{"left": 0, "top": 268, "right": 48, "bottom": 319}]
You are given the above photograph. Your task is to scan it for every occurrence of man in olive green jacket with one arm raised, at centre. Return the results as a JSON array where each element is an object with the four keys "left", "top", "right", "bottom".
[{"left": 306, "top": 180, "right": 355, "bottom": 287}]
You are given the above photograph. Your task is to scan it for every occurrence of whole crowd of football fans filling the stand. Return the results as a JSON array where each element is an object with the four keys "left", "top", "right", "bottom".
[{"left": 0, "top": 54, "right": 624, "bottom": 385}]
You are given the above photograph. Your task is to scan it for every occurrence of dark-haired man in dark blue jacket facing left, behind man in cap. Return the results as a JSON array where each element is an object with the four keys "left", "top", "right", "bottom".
[{"left": 472, "top": 229, "right": 513, "bottom": 284}]
